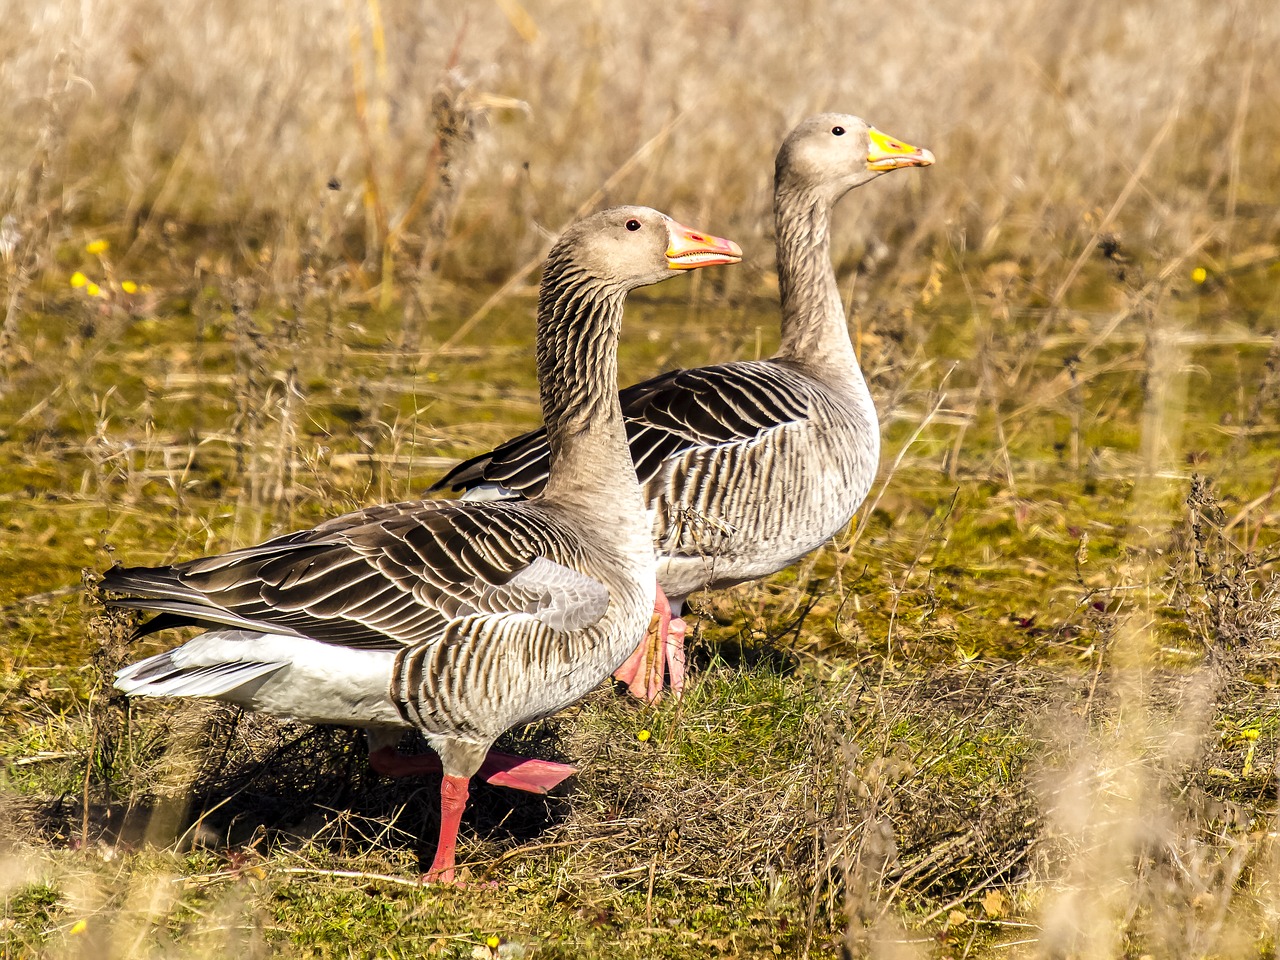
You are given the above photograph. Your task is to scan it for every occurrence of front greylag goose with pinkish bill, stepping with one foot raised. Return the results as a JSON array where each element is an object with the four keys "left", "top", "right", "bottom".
[{"left": 102, "top": 207, "right": 741, "bottom": 882}]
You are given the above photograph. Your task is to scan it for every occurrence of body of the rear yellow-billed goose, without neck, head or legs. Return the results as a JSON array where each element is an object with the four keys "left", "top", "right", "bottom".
[{"left": 436, "top": 360, "right": 879, "bottom": 596}]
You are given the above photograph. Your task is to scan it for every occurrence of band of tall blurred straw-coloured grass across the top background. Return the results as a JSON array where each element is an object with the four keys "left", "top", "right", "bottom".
[{"left": 0, "top": 0, "right": 1280, "bottom": 307}]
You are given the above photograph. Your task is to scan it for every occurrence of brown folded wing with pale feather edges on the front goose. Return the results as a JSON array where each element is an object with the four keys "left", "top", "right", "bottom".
[{"left": 102, "top": 500, "right": 609, "bottom": 649}]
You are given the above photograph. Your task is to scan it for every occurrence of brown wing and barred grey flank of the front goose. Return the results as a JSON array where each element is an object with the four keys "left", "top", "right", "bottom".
[{"left": 104, "top": 500, "right": 652, "bottom": 750}]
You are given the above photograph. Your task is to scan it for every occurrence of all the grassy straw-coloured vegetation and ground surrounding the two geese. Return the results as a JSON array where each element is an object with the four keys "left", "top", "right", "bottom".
[{"left": 0, "top": 0, "right": 1280, "bottom": 957}]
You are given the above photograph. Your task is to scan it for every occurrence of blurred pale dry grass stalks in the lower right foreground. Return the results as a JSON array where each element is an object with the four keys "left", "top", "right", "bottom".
[{"left": 1037, "top": 288, "right": 1280, "bottom": 959}]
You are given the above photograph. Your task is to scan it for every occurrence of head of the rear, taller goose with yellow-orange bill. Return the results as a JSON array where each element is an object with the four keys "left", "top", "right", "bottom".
[{"left": 774, "top": 114, "right": 933, "bottom": 202}]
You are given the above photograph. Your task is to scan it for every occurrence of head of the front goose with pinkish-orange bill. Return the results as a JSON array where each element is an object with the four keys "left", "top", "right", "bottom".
[{"left": 548, "top": 206, "right": 742, "bottom": 291}]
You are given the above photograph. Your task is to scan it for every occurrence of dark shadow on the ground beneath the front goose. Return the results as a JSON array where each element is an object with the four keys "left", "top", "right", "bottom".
[{"left": 15, "top": 708, "right": 573, "bottom": 870}]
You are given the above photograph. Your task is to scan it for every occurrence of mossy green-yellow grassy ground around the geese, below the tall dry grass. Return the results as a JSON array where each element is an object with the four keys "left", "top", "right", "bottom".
[{"left": 0, "top": 263, "right": 1277, "bottom": 957}]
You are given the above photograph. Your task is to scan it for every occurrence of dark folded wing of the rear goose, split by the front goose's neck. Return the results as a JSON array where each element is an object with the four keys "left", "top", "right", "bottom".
[{"left": 431, "top": 361, "right": 810, "bottom": 498}]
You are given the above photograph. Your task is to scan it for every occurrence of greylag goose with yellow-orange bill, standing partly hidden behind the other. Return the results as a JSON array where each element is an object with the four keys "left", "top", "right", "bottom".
[{"left": 431, "top": 114, "right": 933, "bottom": 701}]
